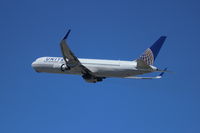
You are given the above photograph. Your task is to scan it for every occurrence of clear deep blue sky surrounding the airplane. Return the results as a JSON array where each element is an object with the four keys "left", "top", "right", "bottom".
[{"left": 0, "top": 0, "right": 200, "bottom": 133}]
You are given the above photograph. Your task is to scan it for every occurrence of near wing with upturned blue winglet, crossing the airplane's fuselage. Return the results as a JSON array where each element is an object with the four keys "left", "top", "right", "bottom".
[{"left": 60, "top": 30, "right": 94, "bottom": 76}]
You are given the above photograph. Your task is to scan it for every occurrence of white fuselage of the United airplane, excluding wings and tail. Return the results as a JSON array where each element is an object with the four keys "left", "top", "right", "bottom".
[{"left": 32, "top": 57, "right": 156, "bottom": 77}]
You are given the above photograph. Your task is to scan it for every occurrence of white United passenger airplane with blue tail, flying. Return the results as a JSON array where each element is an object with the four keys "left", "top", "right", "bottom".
[{"left": 32, "top": 30, "right": 167, "bottom": 83}]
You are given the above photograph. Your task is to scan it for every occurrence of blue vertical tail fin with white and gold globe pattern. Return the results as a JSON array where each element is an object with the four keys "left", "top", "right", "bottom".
[{"left": 139, "top": 36, "right": 167, "bottom": 65}]
